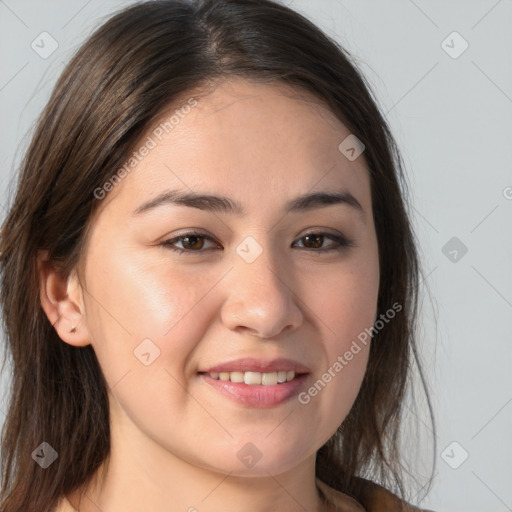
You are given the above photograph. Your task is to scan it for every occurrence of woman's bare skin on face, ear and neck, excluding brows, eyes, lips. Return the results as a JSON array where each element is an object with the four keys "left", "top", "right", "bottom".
[{"left": 39, "top": 78, "right": 379, "bottom": 512}]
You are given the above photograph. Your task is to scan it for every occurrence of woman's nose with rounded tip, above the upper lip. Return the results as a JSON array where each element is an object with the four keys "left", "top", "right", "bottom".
[{"left": 221, "top": 243, "right": 303, "bottom": 339}]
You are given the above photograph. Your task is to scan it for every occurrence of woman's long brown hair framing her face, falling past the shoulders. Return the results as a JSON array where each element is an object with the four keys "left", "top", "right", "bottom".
[{"left": 0, "top": 0, "right": 433, "bottom": 512}]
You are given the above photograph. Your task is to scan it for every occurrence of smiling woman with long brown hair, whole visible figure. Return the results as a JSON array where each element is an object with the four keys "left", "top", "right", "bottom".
[{"left": 1, "top": 0, "right": 436, "bottom": 512}]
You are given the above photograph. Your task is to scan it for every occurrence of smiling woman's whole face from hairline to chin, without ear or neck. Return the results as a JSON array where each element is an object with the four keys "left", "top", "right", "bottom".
[{"left": 72, "top": 79, "right": 379, "bottom": 475}]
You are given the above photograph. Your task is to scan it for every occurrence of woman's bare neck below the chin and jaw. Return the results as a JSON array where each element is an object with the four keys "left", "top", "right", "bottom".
[{"left": 69, "top": 412, "right": 326, "bottom": 512}]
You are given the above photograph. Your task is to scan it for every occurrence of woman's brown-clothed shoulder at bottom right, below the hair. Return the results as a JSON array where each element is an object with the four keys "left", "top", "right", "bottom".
[{"left": 317, "top": 478, "right": 434, "bottom": 512}]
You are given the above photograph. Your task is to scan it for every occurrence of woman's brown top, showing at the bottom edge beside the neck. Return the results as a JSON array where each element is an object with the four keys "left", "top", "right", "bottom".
[{"left": 55, "top": 478, "right": 433, "bottom": 512}]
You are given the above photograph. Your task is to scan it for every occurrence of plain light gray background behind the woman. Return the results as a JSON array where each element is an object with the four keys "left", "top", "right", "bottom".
[{"left": 0, "top": 0, "right": 512, "bottom": 512}]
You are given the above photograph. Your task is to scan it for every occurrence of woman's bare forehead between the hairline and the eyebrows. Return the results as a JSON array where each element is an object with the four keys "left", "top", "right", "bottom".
[{"left": 94, "top": 79, "right": 371, "bottom": 222}]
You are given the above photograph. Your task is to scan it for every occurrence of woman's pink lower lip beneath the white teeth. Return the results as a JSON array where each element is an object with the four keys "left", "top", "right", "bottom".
[{"left": 200, "top": 373, "right": 308, "bottom": 408}]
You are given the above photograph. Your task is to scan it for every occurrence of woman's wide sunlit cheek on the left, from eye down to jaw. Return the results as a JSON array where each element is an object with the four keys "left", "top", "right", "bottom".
[{"left": 80, "top": 253, "right": 218, "bottom": 435}]
